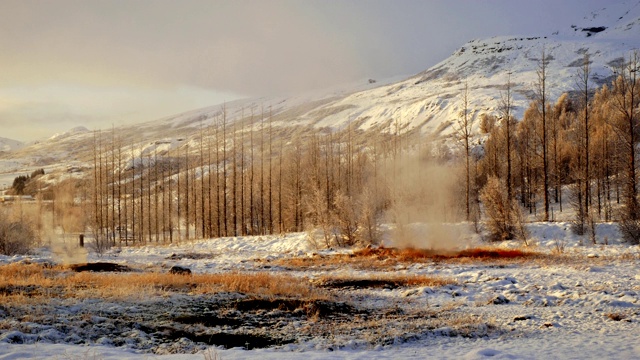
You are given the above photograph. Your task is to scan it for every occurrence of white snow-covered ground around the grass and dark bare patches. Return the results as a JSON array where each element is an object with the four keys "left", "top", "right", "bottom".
[{"left": 0, "top": 222, "right": 640, "bottom": 359}]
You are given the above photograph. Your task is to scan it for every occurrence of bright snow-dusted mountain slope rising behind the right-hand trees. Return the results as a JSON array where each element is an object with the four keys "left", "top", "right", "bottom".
[{"left": 296, "top": 1, "right": 640, "bottom": 139}]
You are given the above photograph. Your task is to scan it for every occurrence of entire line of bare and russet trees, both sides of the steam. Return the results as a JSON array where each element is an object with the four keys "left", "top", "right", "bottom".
[{"left": 63, "top": 50, "right": 640, "bottom": 246}]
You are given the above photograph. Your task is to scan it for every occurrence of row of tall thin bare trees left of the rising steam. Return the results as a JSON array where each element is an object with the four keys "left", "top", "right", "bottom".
[{"left": 89, "top": 108, "right": 430, "bottom": 246}]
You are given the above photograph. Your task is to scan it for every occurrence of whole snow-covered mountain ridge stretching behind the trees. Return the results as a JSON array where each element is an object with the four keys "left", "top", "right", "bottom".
[{"left": 0, "top": 0, "right": 640, "bottom": 176}]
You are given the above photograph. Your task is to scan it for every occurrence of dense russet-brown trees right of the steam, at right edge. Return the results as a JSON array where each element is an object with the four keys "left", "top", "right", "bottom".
[{"left": 458, "top": 51, "right": 640, "bottom": 243}]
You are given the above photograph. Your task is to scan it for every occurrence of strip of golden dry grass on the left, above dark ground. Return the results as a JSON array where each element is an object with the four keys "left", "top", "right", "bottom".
[{"left": 0, "top": 264, "right": 324, "bottom": 303}]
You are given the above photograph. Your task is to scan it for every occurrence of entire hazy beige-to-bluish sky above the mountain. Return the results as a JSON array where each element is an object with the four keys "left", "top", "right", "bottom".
[{"left": 0, "top": 0, "right": 608, "bottom": 141}]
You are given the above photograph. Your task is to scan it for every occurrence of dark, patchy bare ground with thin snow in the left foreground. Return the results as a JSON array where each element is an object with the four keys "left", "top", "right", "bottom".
[{"left": 0, "top": 278, "right": 494, "bottom": 354}]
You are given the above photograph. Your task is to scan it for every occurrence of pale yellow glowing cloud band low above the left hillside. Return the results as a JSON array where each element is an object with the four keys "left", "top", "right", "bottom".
[{"left": 0, "top": 84, "right": 239, "bottom": 140}]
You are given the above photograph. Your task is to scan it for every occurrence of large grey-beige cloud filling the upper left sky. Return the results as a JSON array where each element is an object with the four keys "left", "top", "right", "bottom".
[{"left": 0, "top": 0, "right": 362, "bottom": 94}]
